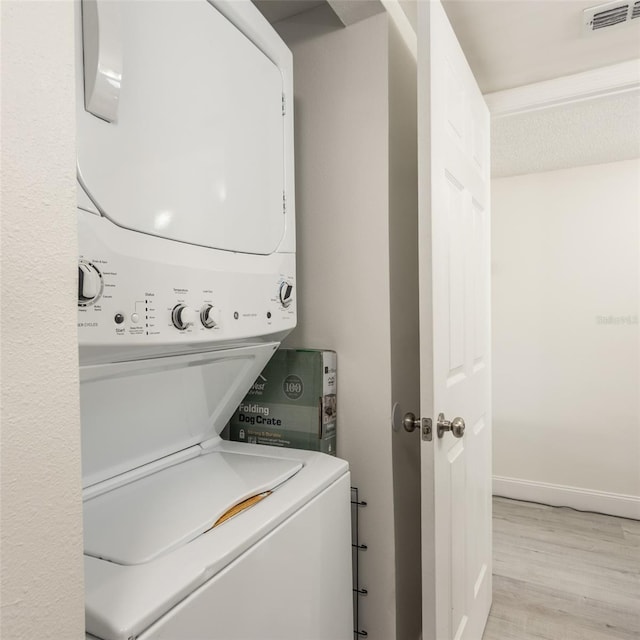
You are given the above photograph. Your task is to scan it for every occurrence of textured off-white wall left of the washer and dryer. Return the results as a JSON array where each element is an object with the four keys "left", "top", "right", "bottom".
[{"left": 0, "top": 2, "right": 84, "bottom": 640}]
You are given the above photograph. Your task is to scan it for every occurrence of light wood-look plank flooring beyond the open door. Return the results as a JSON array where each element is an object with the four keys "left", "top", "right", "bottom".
[{"left": 483, "top": 498, "right": 640, "bottom": 640}]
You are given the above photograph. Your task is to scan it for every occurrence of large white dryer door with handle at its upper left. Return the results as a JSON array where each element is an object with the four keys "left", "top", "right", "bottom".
[{"left": 77, "top": 0, "right": 284, "bottom": 254}]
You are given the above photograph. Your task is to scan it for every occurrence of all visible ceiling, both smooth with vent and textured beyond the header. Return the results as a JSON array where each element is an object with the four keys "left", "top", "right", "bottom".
[{"left": 254, "top": 0, "right": 640, "bottom": 177}]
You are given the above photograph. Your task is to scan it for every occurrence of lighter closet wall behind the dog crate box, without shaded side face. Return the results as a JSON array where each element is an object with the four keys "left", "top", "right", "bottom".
[{"left": 277, "top": 6, "right": 396, "bottom": 640}]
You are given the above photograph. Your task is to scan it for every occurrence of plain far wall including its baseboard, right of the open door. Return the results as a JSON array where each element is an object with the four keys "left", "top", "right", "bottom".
[{"left": 492, "top": 160, "right": 640, "bottom": 517}]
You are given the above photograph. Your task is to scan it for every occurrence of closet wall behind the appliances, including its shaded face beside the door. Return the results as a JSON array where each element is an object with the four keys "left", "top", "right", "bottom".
[{"left": 276, "top": 7, "right": 421, "bottom": 640}]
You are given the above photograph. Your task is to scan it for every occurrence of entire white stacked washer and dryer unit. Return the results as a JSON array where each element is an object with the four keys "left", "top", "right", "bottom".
[{"left": 76, "top": 0, "right": 353, "bottom": 640}]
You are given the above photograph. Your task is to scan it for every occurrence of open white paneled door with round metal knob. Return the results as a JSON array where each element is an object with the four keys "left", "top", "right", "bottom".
[{"left": 418, "top": 2, "right": 491, "bottom": 640}]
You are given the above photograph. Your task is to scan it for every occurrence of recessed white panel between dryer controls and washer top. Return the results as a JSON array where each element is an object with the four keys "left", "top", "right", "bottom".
[{"left": 80, "top": 342, "right": 278, "bottom": 490}]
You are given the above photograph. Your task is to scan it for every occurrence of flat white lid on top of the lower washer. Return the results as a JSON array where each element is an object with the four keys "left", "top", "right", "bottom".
[{"left": 84, "top": 451, "right": 302, "bottom": 565}]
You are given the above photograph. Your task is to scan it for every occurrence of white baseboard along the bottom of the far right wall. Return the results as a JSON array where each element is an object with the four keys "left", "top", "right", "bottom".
[{"left": 493, "top": 476, "right": 640, "bottom": 520}]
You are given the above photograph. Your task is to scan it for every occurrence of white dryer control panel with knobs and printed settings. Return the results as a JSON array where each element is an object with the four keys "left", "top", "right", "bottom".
[{"left": 78, "top": 211, "right": 296, "bottom": 363}]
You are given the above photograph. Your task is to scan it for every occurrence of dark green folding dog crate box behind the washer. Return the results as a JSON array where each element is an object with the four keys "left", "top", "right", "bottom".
[{"left": 228, "top": 349, "right": 337, "bottom": 455}]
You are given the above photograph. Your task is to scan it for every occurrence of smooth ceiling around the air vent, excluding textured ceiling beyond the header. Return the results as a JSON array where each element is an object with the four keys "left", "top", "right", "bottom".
[{"left": 254, "top": 0, "right": 640, "bottom": 93}]
